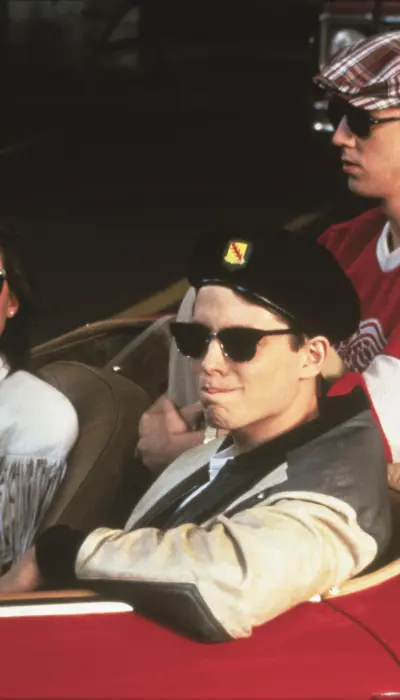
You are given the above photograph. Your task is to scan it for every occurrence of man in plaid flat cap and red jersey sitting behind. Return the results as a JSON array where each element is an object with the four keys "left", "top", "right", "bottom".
[{"left": 139, "top": 32, "right": 400, "bottom": 476}]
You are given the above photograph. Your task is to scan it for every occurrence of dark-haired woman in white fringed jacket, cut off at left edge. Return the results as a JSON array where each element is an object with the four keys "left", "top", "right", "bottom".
[{"left": 0, "top": 230, "right": 78, "bottom": 571}]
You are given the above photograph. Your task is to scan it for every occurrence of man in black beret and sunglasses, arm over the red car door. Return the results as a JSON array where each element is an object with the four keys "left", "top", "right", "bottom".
[{"left": 0, "top": 231, "right": 390, "bottom": 642}]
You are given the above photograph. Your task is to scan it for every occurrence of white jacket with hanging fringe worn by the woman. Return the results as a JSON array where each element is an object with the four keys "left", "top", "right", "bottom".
[{"left": 0, "top": 357, "right": 78, "bottom": 572}]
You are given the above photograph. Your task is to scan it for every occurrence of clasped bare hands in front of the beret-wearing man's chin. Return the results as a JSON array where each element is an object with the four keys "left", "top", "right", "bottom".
[{"left": 137, "top": 395, "right": 204, "bottom": 474}]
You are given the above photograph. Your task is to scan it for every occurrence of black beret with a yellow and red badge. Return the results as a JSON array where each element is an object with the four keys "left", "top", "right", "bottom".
[{"left": 187, "top": 228, "right": 360, "bottom": 343}]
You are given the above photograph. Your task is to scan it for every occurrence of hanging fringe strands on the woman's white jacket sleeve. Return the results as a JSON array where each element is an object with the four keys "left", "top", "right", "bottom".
[{"left": 0, "top": 456, "right": 67, "bottom": 572}]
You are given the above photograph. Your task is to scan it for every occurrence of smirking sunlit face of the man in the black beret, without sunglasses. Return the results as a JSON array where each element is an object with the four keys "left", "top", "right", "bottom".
[{"left": 191, "top": 286, "right": 325, "bottom": 442}]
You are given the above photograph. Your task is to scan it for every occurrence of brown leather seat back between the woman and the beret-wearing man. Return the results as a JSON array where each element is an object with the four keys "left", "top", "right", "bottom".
[{"left": 40, "top": 362, "right": 150, "bottom": 531}]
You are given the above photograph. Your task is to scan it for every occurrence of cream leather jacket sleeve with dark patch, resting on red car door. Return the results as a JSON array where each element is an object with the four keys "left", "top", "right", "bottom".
[{"left": 76, "top": 493, "right": 377, "bottom": 641}]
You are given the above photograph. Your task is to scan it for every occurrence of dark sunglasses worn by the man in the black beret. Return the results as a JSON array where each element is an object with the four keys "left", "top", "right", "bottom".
[{"left": 170, "top": 321, "right": 296, "bottom": 362}]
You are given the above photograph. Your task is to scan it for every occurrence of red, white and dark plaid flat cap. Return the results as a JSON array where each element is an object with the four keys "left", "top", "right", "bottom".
[{"left": 314, "top": 32, "right": 400, "bottom": 110}]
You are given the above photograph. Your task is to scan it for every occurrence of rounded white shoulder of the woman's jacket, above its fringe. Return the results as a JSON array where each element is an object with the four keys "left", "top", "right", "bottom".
[{"left": 0, "top": 371, "right": 78, "bottom": 459}]
